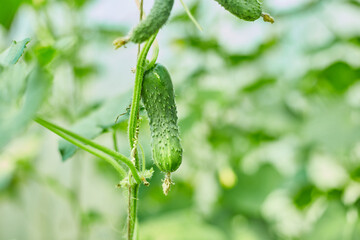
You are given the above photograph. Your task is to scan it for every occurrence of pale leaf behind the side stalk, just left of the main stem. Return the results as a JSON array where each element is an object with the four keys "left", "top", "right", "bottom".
[{"left": 59, "top": 92, "right": 132, "bottom": 161}]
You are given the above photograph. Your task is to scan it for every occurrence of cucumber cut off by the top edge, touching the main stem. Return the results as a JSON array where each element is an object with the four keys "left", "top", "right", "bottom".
[{"left": 130, "top": 0, "right": 174, "bottom": 43}]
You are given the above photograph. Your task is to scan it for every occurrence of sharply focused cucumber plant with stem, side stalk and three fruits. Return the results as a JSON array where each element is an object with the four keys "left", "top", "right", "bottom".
[{"left": 34, "top": 0, "right": 274, "bottom": 240}]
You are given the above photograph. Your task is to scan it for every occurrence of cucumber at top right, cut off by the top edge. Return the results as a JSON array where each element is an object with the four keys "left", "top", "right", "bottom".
[{"left": 215, "top": 0, "right": 262, "bottom": 21}]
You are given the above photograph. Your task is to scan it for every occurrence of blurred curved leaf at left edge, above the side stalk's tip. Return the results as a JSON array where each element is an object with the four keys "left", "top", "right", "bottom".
[{"left": 0, "top": 66, "right": 52, "bottom": 149}]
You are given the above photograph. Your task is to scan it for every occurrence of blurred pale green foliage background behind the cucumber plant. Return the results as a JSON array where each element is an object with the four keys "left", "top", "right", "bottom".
[{"left": 0, "top": 0, "right": 360, "bottom": 240}]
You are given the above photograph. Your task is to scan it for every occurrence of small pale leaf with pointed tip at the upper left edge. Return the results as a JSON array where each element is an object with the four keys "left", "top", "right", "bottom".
[{"left": 0, "top": 38, "right": 30, "bottom": 66}]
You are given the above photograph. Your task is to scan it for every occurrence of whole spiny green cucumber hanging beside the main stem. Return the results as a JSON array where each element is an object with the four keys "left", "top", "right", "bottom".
[{"left": 141, "top": 64, "right": 183, "bottom": 173}]
